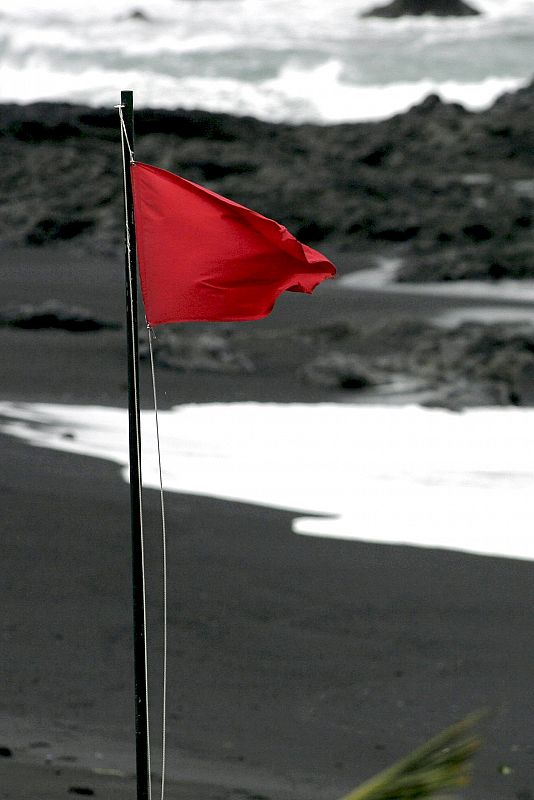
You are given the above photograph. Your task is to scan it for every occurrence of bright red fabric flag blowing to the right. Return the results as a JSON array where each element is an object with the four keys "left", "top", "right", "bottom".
[{"left": 131, "top": 162, "right": 336, "bottom": 325}]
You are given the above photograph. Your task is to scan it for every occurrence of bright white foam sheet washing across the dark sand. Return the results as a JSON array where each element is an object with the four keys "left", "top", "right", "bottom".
[{"left": 0, "top": 402, "right": 534, "bottom": 560}]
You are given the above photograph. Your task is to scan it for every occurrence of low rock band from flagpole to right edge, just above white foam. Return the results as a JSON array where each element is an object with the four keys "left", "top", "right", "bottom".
[{"left": 135, "top": 318, "right": 534, "bottom": 410}]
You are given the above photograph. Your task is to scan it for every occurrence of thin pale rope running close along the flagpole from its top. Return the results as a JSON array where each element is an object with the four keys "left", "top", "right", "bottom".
[{"left": 116, "top": 105, "right": 152, "bottom": 800}]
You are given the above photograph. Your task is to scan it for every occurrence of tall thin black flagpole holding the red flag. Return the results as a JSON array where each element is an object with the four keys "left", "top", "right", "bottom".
[{"left": 121, "top": 91, "right": 150, "bottom": 800}]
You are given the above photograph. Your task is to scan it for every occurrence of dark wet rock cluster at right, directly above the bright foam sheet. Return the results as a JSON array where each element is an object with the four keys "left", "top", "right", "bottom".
[{"left": 294, "top": 319, "right": 534, "bottom": 409}]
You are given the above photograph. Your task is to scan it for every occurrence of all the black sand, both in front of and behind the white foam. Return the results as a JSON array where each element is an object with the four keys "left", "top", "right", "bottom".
[{"left": 0, "top": 92, "right": 534, "bottom": 800}]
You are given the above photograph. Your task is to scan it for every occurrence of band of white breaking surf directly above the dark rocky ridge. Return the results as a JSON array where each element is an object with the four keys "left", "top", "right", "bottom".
[{"left": 0, "top": 57, "right": 525, "bottom": 123}]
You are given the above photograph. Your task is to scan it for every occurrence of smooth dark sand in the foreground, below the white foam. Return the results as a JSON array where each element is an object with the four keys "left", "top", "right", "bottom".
[{"left": 0, "top": 424, "right": 534, "bottom": 800}]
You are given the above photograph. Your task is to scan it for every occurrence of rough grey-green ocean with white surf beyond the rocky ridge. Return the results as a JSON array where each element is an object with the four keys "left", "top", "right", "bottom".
[{"left": 0, "top": 0, "right": 534, "bottom": 123}]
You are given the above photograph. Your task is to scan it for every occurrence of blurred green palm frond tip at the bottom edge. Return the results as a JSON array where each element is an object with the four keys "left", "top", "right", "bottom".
[{"left": 342, "top": 713, "right": 484, "bottom": 800}]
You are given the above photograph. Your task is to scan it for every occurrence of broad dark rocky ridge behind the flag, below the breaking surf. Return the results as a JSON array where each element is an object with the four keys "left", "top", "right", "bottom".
[{"left": 0, "top": 78, "right": 534, "bottom": 281}]
